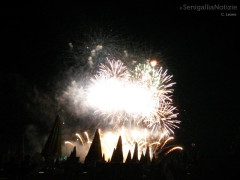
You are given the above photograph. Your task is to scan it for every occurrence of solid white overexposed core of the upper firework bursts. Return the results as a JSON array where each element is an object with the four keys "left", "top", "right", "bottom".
[{"left": 88, "top": 78, "right": 156, "bottom": 115}]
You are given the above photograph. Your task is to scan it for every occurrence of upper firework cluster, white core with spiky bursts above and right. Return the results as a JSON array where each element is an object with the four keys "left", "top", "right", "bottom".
[{"left": 87, "top": 60, "right": 180, "bottom": 134}]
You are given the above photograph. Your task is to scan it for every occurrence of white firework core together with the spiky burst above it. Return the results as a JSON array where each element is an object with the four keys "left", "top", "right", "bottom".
[{"left": 87, "top": 60, "right": 157, "bottom": 124}]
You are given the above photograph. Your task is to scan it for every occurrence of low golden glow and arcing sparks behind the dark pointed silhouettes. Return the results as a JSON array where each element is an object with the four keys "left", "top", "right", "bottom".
[{"left": 71, "top": 127, "right": 182, "bottom": 161}]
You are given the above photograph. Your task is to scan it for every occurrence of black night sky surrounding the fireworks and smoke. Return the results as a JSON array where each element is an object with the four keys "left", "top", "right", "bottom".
[{"left": 0, "top": 3, "right": 239, "bottom": 158}]
